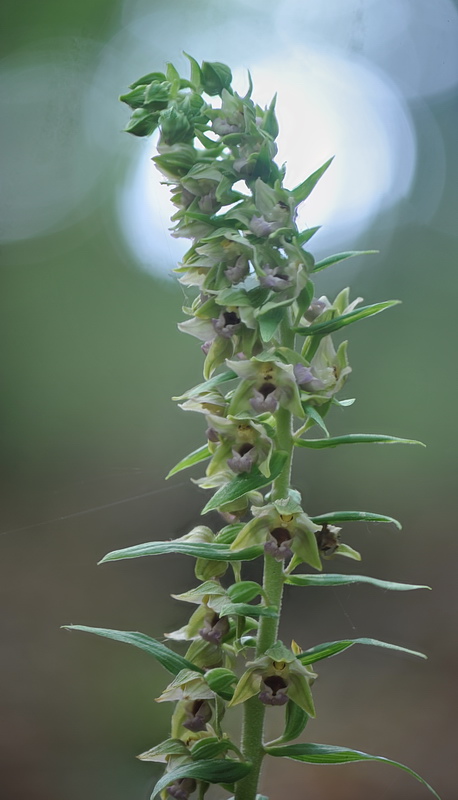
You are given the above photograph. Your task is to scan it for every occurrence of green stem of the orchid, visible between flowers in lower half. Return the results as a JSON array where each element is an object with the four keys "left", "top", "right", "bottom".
[{"left": 235, "top": 396, "right": 293, "bottom": 800}]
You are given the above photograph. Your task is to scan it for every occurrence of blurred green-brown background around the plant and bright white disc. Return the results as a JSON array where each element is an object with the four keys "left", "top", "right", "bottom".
[{"left": 0, "top": 0, "right": 458, "bottom": 800}]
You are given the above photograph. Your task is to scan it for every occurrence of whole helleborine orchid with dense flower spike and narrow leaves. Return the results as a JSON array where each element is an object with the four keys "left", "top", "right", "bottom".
[{"left": 62, "top": 56, "right": 438, "bottom": 800}]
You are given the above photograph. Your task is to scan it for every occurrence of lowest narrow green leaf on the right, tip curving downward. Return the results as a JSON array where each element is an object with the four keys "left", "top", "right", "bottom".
[{"left": 265, "top": 742, "right": 441, "bottom": 800}]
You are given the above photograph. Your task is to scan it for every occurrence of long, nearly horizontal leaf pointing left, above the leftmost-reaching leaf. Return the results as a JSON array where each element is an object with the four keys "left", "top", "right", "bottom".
[{"left": 99, "top": 541, "right": 263, "bottom": 564}]
